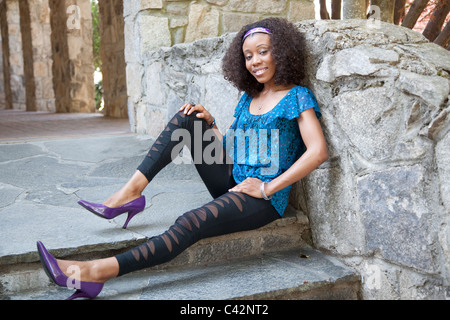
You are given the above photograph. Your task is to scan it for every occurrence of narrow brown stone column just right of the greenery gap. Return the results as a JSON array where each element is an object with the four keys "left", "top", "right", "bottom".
[{"left": 99, "top": 0, "right": 128, "bottom": 118}]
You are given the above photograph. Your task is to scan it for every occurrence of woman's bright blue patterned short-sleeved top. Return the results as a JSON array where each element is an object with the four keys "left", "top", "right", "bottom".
[{"left": 223, "top": 86, "right": 321, "bottom": 216}]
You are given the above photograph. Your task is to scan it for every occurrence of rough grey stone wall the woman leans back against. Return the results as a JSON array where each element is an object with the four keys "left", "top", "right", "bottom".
[{"left": 127, "top": 20, "right": 450, "bottom": 299}]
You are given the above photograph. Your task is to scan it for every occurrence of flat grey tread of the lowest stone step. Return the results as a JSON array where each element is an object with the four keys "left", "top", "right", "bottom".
[{"left": 3, "top": 246, "right": 360, "bottom": 302}]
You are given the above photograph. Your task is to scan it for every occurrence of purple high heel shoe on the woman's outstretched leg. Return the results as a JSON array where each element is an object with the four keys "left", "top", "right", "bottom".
[{"left": 37, "top": 241, "right": 103, "bottom": 300}]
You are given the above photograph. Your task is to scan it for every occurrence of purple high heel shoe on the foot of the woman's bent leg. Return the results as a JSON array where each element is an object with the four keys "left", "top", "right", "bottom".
[{"left": 78, "top": 196, "right": 145, "bottom": 229}]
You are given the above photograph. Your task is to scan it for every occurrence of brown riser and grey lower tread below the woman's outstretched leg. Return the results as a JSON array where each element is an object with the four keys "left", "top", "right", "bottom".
[{"left": 0, "top": 208, "right": 360, "bottom": 300}]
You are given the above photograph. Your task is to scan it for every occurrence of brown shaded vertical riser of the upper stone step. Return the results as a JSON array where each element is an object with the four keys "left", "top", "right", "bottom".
[{"left": 0, "top": 207, "right": 309, "bottom": 297}]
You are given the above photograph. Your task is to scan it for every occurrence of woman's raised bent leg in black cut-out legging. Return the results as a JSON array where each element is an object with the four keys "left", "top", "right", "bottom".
[{"left": 103, "top": 112, "right": 233, "bottom": 208}]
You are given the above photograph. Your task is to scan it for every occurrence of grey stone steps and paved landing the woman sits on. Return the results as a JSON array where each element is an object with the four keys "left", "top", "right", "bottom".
[{"left": 0, "top": 136, "right": 360, "bottom": 300}]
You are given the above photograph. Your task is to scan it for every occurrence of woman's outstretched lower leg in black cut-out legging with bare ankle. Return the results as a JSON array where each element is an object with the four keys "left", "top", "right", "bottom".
[{"left": 58, "top": 192, "right": 280, "bottom": 283}]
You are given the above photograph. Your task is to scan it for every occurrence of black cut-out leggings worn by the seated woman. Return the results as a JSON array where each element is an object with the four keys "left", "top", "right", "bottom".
[{"left": 116, "top": 112, "right": 280, "bottom": 276}]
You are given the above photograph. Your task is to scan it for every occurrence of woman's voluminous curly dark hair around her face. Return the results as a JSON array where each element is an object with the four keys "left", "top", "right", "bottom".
[{"left": 222, "top": 18, "right": 305, "bottom": 97}]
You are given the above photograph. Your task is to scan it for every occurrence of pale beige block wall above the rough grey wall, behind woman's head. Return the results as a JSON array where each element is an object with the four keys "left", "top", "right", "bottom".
[{"left": 124, "top": 0, "right": 315, "bottom": 50}]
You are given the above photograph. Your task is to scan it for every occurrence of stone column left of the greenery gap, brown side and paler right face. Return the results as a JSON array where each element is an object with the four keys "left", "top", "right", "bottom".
[{"left": 49, "top": 0, "right": 95, "bottom": 113}]
